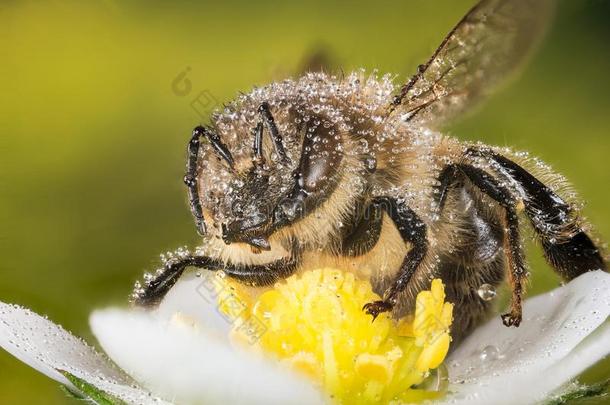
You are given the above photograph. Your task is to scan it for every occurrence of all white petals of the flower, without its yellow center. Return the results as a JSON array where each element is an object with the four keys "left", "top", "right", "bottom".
[{"left": 0, "top": 271, "right": 610, "bottom": 404}]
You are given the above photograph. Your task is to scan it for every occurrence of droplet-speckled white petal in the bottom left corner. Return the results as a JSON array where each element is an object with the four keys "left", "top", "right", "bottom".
[{"left": 0, "top": 302, "right": 160, "bottom": 404}]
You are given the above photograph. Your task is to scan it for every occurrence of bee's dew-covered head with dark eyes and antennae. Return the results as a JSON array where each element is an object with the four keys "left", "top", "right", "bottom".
[{"left": 187, "top": 103, "right": 354, "bottom": 251}]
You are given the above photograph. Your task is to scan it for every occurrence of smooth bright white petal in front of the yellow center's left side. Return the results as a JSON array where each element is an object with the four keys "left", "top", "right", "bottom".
[{"left": 90, "top": 309, "right": 323, "bottom": 404}]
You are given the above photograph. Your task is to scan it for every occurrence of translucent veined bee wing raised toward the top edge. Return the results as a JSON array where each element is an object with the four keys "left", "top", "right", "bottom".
[{"left": 391, "top": 0, "right": 554, "bottom": 127}]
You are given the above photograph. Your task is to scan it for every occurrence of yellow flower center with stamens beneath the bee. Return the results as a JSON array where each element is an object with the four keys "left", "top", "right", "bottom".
[{"left": 218, "top": 268, "right": 453, "bottom": 404}]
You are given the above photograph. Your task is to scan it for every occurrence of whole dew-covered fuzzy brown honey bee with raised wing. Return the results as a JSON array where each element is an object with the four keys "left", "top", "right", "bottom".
[{"left": 135, "top": 0, "right": 606, "bottom": 340}]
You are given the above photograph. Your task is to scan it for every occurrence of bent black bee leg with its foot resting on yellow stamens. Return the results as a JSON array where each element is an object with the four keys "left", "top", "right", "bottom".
[{"left": 362, "top": 197, "right": 428, "bottom": 321}]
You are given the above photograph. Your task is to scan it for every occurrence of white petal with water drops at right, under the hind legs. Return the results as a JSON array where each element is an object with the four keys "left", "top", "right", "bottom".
[{"left": 446, "top": 271, "right": 610, "bottom": 405}]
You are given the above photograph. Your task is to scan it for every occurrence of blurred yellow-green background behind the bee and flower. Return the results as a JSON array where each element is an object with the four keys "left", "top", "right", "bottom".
[{"left": 0, "top": 0, "right": 610, "bottom": 404}]
